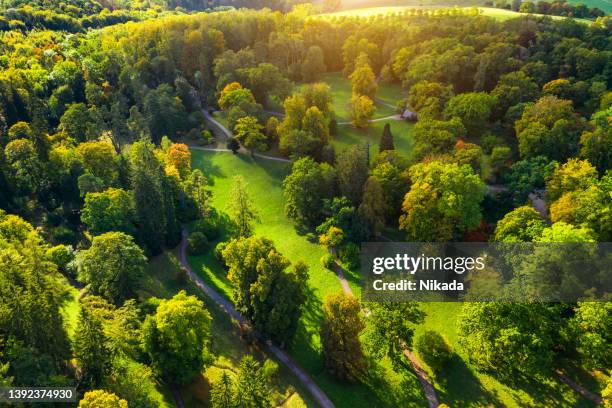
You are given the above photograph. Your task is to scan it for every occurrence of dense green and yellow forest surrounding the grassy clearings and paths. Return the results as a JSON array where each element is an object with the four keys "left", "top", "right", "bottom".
[{"left": 0, "top": 0, "right": 612, "bottom": 407}]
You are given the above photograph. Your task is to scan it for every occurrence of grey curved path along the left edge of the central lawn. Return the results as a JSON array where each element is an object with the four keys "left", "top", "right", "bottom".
[{"left": 179, "top": 230, "right": 334, "bottom": 408}]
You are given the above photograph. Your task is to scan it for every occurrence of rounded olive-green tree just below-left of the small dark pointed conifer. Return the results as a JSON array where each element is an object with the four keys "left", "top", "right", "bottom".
[{"left": 336, "top": 146, "right": 369, "bottom": 205}]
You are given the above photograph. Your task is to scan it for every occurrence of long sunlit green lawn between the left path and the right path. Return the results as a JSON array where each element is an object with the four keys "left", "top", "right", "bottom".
[{"left": 190, "top": 151, "right": 424, "bottom": 408}]
